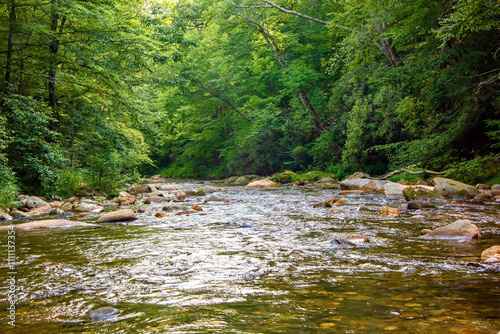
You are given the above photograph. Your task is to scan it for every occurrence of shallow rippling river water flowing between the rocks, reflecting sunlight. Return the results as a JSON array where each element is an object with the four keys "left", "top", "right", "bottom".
[{"left": 0, "top": 182, "right": 500, "bottom": 333}]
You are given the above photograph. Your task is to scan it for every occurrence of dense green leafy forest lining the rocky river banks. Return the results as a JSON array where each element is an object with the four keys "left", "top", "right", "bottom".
[{"left": 0, "top": 0, "right": 500, "bottom": 203}]
